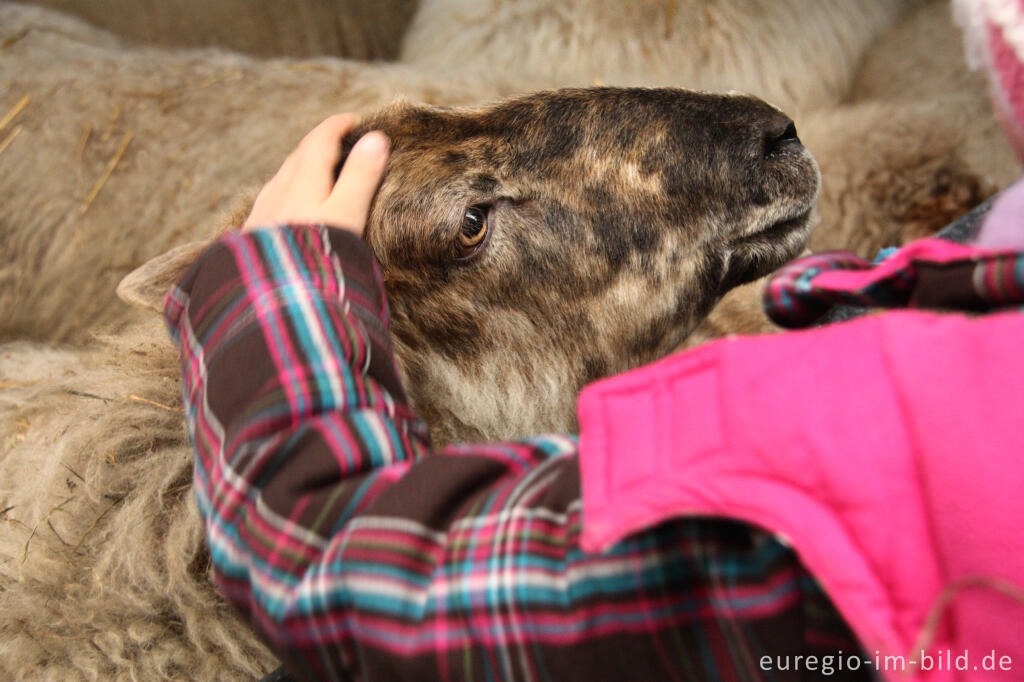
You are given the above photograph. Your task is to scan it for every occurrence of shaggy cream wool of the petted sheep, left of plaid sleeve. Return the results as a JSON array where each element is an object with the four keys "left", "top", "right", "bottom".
[{"left": 0, "top": 324, "right": 275, "bottom": 680}]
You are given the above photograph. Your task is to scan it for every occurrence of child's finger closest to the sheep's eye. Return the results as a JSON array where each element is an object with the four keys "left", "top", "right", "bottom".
[{"left": 324, "top": 130, "right": 391, "bottom": 233}]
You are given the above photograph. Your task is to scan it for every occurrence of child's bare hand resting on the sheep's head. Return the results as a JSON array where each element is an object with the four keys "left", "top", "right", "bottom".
[{"left": 242, "top": 114, "right": 391, "bottom": 236}]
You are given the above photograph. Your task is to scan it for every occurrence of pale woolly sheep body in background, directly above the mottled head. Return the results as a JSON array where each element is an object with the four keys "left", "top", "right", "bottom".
[{"left": 399, "top": 0, "right": 922, "bottom": 114}]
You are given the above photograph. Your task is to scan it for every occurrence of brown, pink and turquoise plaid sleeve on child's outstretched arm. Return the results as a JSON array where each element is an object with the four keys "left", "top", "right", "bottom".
[{"left": 166, "top": 225, "right": 864, "bottom": 680}]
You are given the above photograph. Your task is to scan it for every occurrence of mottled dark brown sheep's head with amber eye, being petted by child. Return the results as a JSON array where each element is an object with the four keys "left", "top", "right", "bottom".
[{"left": 345, "top": 88, "right": 819, "bottom": 440}]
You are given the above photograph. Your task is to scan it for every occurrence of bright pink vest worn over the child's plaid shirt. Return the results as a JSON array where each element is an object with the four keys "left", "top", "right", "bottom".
[{"left": 579, "top": 312, "right": 1024, "bottom": 681}]
